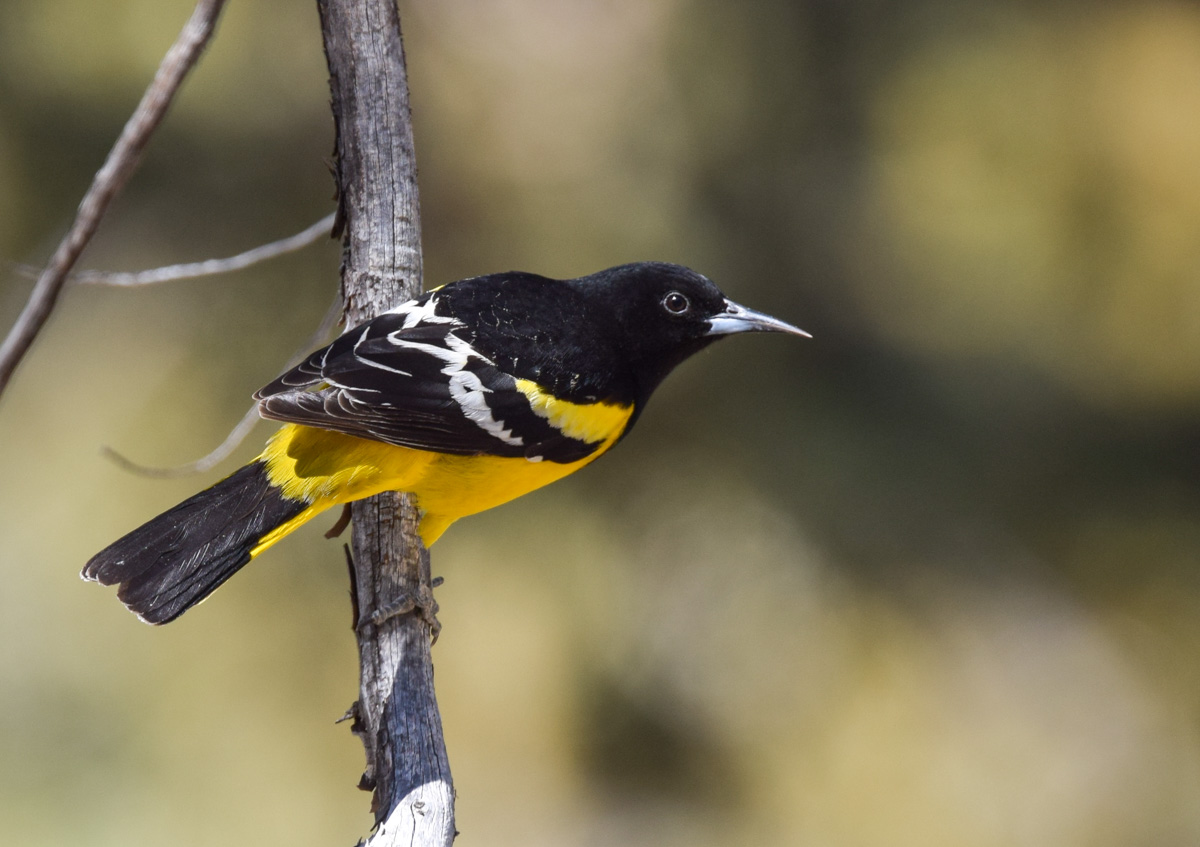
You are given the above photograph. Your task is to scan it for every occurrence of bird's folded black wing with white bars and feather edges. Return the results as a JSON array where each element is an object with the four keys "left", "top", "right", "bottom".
[{"left": 254, "top": 293, "right": 599, "bottom": 462}]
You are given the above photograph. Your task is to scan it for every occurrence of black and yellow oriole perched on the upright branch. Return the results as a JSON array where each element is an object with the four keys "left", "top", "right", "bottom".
[{"left": 82, "top": 262, "right": 811, "bottom": 624}]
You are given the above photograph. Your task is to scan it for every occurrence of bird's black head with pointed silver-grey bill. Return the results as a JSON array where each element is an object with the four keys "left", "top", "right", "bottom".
[{"left": 571, "top": 262, "right": 808, "bottom": 401}]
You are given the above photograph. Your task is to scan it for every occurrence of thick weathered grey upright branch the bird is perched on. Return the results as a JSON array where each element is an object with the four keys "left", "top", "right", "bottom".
[{"left": 317, "top": 0, "right": 455, "bottom": 847}]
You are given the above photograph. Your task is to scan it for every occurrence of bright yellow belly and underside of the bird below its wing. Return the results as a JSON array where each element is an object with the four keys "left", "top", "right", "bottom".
[{"left": 252, "top": 414, "right": 628, "bottom": 555}]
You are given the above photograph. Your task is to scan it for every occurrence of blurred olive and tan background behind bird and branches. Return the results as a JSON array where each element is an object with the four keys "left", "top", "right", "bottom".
[{"left": 0, "top": 0, "right": 1200, "bottom": 847}]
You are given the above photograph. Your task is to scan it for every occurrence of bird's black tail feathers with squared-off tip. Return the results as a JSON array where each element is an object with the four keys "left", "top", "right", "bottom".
[{"left": 83, "top": 462, "right": 308, "bottom": 624}]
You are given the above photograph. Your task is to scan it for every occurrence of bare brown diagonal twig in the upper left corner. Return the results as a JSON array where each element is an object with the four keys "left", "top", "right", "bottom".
[{"left": 0, "top": 0, "right": 226, "bottom": 394}]
